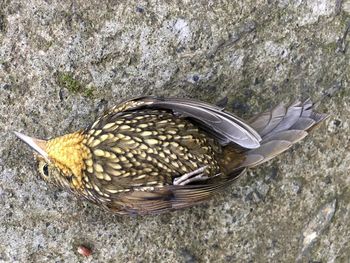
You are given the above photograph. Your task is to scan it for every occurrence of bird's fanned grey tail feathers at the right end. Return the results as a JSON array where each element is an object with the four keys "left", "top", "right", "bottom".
[{"left": 240, "top": 99, "right": 328, "bottom": 167}]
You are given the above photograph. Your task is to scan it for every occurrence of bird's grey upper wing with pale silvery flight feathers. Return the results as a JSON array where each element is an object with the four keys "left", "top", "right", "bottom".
[{"left": 109, "top": 97, "right": 261, "bottom": 149}]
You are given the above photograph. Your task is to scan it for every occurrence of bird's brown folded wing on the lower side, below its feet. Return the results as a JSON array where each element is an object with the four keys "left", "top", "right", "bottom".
[{"left": 108, "top": 169, "right": 245, "bottom": 215}]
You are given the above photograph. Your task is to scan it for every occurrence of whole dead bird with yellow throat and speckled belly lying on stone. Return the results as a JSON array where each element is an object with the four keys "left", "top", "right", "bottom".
[{"left": 15, "top": 97, "right": 327, "bottom": 215}]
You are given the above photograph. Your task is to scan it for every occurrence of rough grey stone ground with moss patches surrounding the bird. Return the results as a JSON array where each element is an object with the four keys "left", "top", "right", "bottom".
[{"left": 0, "top": 0, "right": 350, "bottom": 262}]
